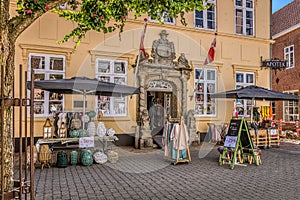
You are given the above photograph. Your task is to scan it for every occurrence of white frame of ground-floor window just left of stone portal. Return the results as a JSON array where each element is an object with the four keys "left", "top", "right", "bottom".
[{"left": 96, "top": 58, "right": 128, "bottom": 117}]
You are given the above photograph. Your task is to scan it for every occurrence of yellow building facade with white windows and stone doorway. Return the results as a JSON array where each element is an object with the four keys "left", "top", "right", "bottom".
[{"left": 11, "top": 0, "right": 272, "bottom": 144}]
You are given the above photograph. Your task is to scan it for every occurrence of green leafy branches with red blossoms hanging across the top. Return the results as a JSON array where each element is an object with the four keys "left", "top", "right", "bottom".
[{"left": 17, "top": 0, "right": 205, "bottom": 46}]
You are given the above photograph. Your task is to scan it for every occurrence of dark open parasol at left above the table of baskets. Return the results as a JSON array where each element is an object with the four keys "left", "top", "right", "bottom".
[{"left": 27, "top": 77, "right": 139, "bottom": 128}]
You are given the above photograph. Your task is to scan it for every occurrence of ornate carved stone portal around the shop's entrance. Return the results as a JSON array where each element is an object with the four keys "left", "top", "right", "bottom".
[{"left": 136, "top": 30, "right": 192, "bottom": 148}]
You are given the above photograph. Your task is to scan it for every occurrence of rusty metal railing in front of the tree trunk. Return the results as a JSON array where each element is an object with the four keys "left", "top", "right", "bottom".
[{"left": 0, "top": 65, "right": 34, "bottom": 200}]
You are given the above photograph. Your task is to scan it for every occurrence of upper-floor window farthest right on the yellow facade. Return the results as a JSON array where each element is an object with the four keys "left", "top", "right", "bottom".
[{"left": 235, "top": 0, "right": 254, "bottom": 36}]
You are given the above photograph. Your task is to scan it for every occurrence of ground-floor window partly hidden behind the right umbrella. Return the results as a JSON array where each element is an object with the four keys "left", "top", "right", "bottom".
[{"left": 235, "top": 72, "right": 254, "bottom": 117}]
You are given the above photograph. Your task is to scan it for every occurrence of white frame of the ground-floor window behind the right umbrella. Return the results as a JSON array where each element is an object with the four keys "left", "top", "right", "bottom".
[{"left": 235, "top": 71, "right": 255, "bottom": 117}]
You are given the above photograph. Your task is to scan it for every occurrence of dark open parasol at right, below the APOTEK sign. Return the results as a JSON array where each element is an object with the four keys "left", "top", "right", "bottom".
[{"left": 211, "top": 85, "right": 299, "bottom": 122}]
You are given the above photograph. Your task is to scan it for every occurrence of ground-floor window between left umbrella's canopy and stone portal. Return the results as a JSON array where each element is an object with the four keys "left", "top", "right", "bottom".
[{"left": 96, "top": 59, "right": 127, "bottom": 116}]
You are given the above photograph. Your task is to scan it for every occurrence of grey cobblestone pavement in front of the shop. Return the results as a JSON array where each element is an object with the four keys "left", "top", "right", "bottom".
[{"left": 29, "top": 143, "right": 300, "bottom": 200}]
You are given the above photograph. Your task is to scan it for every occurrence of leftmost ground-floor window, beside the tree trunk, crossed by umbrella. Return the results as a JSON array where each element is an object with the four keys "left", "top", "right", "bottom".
[{"left": 28, "top": 54, "right": 66, "bottom": 116}]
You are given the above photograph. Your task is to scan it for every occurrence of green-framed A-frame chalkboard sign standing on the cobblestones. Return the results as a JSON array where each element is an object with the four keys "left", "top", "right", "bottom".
[{"left": 219, "top": 118, "right": 259, "bottom": 169}]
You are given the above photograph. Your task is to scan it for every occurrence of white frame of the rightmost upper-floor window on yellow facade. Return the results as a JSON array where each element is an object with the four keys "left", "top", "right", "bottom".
[{"left": 234, "top": 0, "right": 255, "bottom": 36}]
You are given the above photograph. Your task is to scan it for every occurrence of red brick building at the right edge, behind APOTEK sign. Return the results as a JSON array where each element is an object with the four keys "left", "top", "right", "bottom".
[{"left": 272, "top": 0, "right": 300, "bottom": 121}]
